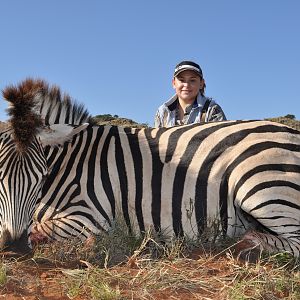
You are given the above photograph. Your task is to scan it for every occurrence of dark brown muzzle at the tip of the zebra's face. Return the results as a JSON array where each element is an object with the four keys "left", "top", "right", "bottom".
[{"left": 0, "top": 230, "right": 31, "bottom": 255}]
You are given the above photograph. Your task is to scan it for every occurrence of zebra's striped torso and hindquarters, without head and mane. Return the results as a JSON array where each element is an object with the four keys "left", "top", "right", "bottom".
[{"left": 35, "top": 121, "right": 300, "bottom": 256}]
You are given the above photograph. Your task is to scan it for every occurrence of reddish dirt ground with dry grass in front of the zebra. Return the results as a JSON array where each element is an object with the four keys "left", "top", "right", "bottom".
[{"left": 0, "top": 246, "right": 300, "bottom": 300}]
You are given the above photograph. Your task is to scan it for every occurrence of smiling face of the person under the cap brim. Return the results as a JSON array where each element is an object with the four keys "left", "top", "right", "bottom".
[{"left": 172, "top": 70, "right": 204, "bottom": 103}]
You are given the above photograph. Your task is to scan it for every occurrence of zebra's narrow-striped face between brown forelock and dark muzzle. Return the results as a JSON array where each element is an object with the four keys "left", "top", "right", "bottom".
[{"left": 0, "top": 129, "right": 48, "bottom": 249}]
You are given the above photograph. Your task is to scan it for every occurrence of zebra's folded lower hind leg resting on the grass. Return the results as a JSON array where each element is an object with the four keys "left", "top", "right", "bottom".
[{"left": 235, "top": 230, "right": 300, "bottom": 262}]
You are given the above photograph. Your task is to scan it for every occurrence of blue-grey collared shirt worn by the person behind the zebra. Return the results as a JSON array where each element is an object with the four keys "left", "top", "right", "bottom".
[{"left": 154, "top": 93, "right": 226, "bottom": 127}]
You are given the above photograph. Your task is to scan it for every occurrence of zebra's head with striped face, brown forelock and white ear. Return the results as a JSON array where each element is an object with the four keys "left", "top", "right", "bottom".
[{"left": 0, "top": 79, "right": 91, "bottom": 253}]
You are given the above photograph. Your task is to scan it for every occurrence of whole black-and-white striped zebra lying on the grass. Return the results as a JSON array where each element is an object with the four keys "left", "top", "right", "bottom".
[{"left": 0, "top": 77, "right": 300, "bottom": 257}]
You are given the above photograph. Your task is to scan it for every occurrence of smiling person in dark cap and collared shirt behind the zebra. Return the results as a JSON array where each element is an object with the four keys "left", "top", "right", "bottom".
[{"left": 154, "top": 61, "right": 226, "bottom": 127}]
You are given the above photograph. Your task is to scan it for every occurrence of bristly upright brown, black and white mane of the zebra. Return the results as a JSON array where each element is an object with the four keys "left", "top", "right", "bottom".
[{"left": 2, "top": 78, "right": 95, "bottom": 150}]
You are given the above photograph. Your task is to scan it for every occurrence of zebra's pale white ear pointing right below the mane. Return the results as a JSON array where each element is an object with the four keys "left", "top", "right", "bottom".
[{"left": 38, "top": 123, "right": 89, "bottom": 147}]
